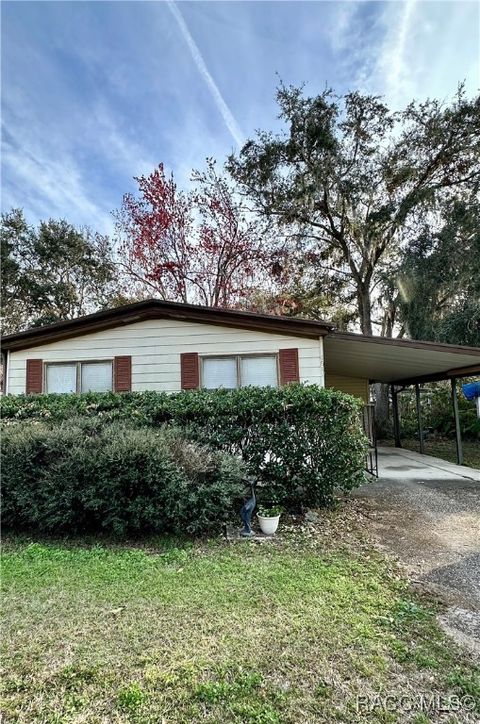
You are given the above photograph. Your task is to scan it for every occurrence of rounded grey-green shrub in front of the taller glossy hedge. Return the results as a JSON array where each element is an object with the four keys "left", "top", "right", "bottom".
[{"left": 2, "top": 418, "right": 244, "bottom": 534}]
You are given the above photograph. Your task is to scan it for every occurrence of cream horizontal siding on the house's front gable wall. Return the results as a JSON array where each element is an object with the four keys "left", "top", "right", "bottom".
[{"left": 8, "top": 319, "right": 324, "bottom": 394}]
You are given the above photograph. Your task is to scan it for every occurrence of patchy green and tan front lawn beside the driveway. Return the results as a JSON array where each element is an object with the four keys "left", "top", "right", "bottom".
[{"left": 2, "top": 512, "right": 480, "bottom": 724}]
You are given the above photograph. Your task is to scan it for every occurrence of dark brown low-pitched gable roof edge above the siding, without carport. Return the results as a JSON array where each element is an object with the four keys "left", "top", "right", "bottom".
[{"left": 2, "top": 299, "right": 333, "bottom": 350}]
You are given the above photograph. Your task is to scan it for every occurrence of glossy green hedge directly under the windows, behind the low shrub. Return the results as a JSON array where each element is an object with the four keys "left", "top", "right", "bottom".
[{"left": 0, "top": 385, "right": 367, "bottom": 510}]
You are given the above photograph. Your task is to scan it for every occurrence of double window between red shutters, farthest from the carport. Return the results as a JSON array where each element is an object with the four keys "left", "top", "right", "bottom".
[{"left": 45, "top": 362, "right": 113, "bottom": 393}]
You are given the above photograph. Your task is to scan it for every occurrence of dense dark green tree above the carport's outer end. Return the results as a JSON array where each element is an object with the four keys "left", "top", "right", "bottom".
[{"left": 398, "top": 196, "right": 480, "bottom": 346}]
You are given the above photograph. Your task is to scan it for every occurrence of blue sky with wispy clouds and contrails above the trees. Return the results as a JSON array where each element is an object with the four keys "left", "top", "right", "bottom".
[{"left": 2, "top": 0, "right": 480, "bottom": 232}]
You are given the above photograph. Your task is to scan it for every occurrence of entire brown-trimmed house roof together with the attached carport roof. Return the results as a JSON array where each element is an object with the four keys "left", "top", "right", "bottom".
[{"left": 2, "top": 299, "right": 480, "bottom": 384}]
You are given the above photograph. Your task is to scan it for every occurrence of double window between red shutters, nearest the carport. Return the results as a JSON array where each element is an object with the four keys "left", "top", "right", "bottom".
[{"left": 202, "top": 354, "right": 278, "bottom": 390}]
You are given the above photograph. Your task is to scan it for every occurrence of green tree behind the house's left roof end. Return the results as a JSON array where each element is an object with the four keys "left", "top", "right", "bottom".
[{"left": 0, "top": 209, "right": 117, "bottom": 333}]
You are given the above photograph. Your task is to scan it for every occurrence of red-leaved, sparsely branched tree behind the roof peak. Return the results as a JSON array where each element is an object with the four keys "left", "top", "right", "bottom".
[{"left": 116, "top": 159, "right": 268, "bottom": 307}]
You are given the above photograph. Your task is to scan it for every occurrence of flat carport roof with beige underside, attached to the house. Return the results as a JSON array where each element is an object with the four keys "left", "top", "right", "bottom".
[{"left": 324, "top": 332, "right": 480, "bottom": 384}]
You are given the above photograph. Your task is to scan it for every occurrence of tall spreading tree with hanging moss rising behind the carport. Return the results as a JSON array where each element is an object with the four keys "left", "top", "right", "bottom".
[{"left": 227, "top": 85, "right": 480, "bottom": 334}]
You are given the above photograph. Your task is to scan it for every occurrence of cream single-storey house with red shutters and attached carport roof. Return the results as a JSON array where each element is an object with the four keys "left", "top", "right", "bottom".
[{"left": 2, "top": 299, "right": 480, "bottom": 403}]
